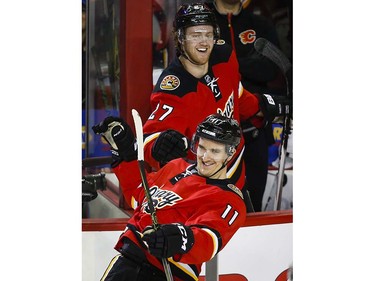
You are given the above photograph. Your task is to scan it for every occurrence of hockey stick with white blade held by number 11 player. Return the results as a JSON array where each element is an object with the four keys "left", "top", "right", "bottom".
[{"left": 132, "top": 109, "right": 173, "bottom": 281}]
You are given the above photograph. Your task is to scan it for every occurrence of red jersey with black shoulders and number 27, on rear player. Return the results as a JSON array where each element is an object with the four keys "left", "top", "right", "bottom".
[{"left": 143, "top": 43, "right": 259, "bottom": 189}]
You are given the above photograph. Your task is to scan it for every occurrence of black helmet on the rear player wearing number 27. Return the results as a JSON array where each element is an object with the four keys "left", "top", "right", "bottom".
[{"left": 173, "top": 3, "right": 220, "bottom": 51}]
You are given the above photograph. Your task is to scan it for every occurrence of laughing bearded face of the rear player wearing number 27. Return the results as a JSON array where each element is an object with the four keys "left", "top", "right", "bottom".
[{"left": 183, "top": 25, "right": 215, "bottom": 65}]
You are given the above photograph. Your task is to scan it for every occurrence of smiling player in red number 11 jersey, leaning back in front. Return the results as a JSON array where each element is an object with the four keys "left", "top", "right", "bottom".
[{"left": 93, "top": 114, "right": 246, "bottom": 281}]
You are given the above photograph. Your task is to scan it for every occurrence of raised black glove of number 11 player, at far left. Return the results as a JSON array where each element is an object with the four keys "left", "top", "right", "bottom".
[{"left": 92, "top": 116, "right": 137, "bottom": 164}]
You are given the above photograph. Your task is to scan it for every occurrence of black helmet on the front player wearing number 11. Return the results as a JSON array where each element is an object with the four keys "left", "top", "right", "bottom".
[{"left": 191, "top": 113, "right": 241, "bottom": 154}]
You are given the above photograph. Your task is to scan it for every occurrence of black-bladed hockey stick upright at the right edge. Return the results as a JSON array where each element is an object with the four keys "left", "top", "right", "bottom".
[{"left": 254, "top": 38, "right": 293, "bottom": 210}]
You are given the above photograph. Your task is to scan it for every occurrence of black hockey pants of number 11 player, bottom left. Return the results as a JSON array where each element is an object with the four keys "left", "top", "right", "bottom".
[{"left": 101, "top": 238, "right": 166, "bottom": 281}]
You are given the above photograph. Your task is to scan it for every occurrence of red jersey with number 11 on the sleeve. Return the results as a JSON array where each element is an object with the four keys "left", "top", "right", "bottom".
[{"left": 114, "top": 159, "right": 246, "bottom": 281}]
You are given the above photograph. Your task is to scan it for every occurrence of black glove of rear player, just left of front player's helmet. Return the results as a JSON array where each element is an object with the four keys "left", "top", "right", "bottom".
[{"left": 151, "top": 130, "right": 189, "bottom": 164}]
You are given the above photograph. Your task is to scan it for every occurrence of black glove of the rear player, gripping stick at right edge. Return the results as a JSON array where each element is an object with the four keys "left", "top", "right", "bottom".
[{"left": 256, "top": 94, "right": 293, "bottom": 122}]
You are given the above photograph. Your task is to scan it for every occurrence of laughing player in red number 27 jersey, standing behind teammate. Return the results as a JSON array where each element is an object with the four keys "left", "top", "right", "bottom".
[{"left": 143, "top": 3, "right": 285, "bottom": 195}]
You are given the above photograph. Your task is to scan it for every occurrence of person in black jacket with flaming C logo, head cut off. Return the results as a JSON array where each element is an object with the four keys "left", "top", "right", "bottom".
[{"left": 207, "top": 0, "right": 285, "bottom": 212}]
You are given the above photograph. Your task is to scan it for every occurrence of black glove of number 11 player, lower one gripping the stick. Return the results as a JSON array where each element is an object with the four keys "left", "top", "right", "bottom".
[{"left": 142, "top": 223, "right": 194, "bottom": 258}]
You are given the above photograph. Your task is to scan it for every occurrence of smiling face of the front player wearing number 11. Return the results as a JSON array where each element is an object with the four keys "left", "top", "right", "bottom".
[{"left": 197, "top": 138, "right": 229, "bottom": 179}]
